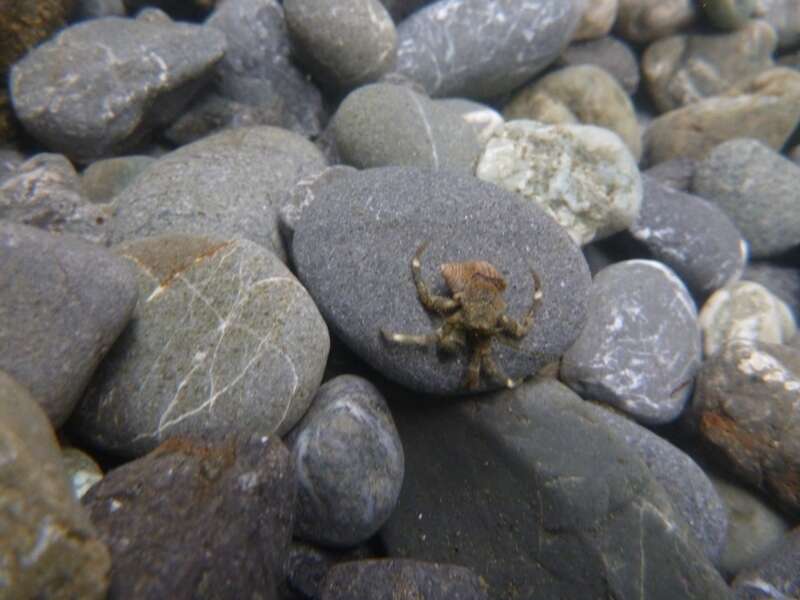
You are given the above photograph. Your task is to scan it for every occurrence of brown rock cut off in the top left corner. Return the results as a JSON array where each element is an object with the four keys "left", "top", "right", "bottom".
[{"left": 0, "top": 0, "right": 77, "bottom": 75}]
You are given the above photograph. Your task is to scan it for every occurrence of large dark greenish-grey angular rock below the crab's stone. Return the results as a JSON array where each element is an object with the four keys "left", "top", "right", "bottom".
[{"left": 381, "top": 379, "right": 729, "bottom": 600}]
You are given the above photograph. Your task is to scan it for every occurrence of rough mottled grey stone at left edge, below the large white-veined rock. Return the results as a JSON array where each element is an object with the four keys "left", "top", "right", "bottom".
[{"left": 0, "top": 153, "right": 112, "bottom": 245}]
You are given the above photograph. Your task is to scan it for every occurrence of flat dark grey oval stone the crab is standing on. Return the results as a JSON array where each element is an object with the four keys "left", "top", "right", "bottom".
[{"left": 292, "top": 168, "right": 590, "bottom": 394}]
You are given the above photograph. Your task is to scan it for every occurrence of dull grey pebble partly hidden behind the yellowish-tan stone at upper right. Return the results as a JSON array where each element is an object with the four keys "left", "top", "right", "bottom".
[{"left": 556, "top": 36, "right": 639, "bottom": 96}]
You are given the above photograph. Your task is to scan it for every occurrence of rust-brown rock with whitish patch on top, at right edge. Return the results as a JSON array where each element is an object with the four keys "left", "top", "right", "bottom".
[{"left": 691, "top": 340, "right": 800, "bottom": 513}]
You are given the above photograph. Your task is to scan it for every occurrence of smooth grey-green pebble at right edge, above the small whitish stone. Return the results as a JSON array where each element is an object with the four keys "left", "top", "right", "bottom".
[{"left": 692, "top": 139, "right": 800, "bottom": 258}]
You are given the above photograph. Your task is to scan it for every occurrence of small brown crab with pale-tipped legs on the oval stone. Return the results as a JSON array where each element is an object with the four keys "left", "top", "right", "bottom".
[{"left": 381, "top": 243, "right": 542, "bottom": 390}]
